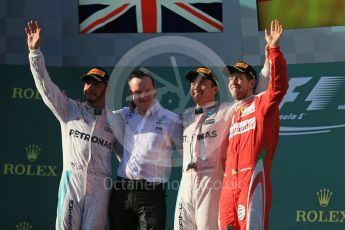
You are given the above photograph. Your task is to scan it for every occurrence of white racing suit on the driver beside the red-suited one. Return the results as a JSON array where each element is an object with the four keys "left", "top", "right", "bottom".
[{"left": 174, "top": 67, "right": 269, "bottom": 230}]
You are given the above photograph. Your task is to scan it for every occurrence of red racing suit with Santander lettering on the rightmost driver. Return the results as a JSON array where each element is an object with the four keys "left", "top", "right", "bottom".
[{"left": 220, "top": 47, "right": 288, "bottom": 230}]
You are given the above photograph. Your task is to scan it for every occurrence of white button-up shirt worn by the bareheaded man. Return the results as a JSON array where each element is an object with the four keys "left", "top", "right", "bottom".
[{"left": 113, "top": 100, "right": 183, "bottom": 183}]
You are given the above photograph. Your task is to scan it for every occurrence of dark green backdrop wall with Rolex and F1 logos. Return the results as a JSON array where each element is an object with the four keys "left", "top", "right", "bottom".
[{"left": 0, "top": 63, "right": 345, "bottom": 230}]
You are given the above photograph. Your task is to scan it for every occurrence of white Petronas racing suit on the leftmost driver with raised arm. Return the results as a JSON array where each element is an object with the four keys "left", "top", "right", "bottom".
[{"left": 29, "top": 49, "right": 121, "bottom": 230}]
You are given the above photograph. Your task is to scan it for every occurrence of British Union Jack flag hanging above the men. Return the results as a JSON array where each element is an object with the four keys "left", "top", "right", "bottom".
[{"left": 79, "top": 0, "right": 223, "bottom": 33}]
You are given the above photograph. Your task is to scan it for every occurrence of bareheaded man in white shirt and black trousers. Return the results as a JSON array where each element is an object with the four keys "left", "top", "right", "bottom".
[{"left": 109, "top": 70, "right": 182, "bottom": 230}]
